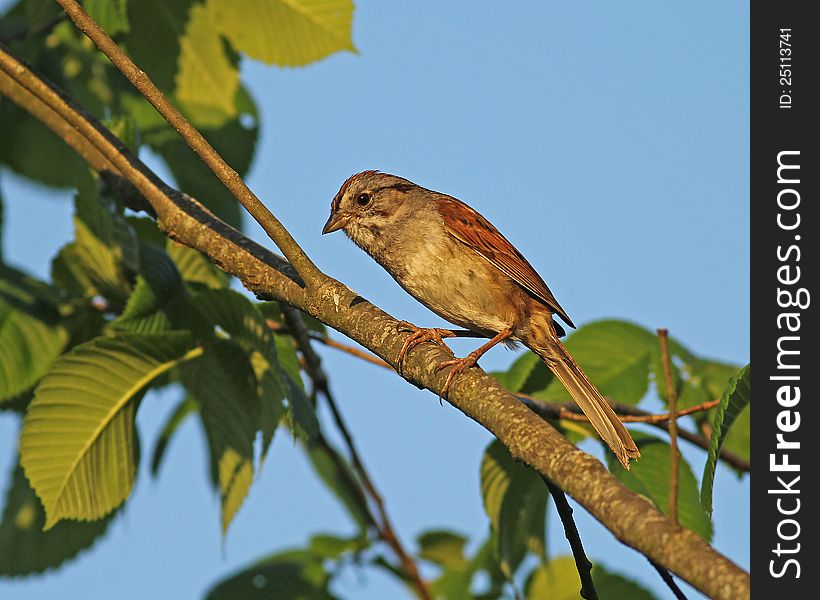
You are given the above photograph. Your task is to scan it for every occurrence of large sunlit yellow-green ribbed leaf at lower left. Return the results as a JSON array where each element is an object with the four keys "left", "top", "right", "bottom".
[{"left": 20, "top": 333, "right": 197, "bottom": 529}]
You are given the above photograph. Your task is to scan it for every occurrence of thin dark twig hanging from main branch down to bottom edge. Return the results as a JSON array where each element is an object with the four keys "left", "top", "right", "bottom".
[{"left": 279, "top": 303, "right": 432, "bottom": 600}]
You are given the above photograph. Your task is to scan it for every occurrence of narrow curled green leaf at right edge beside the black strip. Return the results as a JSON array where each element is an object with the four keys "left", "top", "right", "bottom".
[{"left": 700, "top": 365, "right": 751, "bottom": 515}]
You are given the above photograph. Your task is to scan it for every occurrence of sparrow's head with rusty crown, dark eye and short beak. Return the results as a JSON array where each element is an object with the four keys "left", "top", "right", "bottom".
[{"left": 322, "top": 171, "right": 421, "bottom": 245}]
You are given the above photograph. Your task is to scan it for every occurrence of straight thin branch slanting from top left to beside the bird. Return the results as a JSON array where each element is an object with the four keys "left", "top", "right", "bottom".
[{"left": 57, "top": 0, "right": 328, "bottom": 284}]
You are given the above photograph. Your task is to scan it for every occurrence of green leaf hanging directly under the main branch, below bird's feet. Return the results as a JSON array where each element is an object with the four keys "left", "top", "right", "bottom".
[{"left": 481, "top": 440, "right": 548, "bottom": 580}]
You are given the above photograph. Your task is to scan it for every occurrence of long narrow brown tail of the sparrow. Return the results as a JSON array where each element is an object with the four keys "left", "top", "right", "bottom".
[{"left": 533, "top": 336, "right": 641, "bottom": 469}]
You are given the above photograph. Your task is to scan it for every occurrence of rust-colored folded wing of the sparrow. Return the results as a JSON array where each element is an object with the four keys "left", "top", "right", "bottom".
[{"left": 436, "top": 196, "right": 575, "bottom": 327}]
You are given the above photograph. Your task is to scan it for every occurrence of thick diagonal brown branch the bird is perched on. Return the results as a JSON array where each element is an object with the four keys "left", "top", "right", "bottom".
[{"left": 0, "top": 43, "right": 750, "bottom": 600}]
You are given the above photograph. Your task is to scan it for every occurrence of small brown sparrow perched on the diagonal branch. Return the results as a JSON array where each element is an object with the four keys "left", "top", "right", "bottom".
[{"left": 322, "top": 170, "right": 640, "bottom": 469}]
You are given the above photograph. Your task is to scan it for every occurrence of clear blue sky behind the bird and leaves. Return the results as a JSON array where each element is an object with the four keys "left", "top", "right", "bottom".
[{"left": 0, "top": 1, "right": 749, "bottom": 600}]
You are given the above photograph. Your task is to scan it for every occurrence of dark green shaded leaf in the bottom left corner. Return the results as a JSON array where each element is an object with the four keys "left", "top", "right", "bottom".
[{"left": 0, "top": 466, "right": 113, "bottom": 577}]
